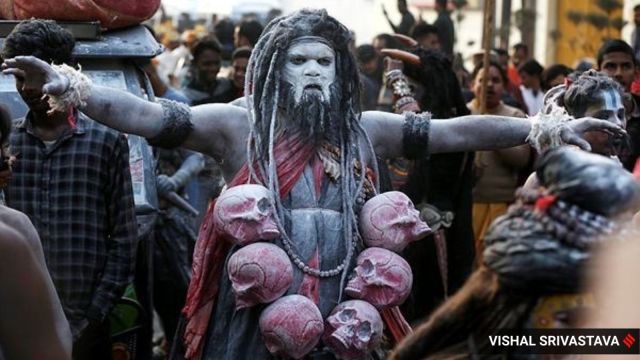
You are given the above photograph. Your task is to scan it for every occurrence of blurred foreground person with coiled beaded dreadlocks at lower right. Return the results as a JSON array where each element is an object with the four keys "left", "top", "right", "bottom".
[{"left": 391, "top": 147, "right": 640, "bottom": 360}]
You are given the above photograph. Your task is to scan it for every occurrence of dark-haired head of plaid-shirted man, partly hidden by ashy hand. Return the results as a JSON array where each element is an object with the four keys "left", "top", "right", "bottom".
[{"left": 2, "top": 20, "right": 75, "bottom": 114}]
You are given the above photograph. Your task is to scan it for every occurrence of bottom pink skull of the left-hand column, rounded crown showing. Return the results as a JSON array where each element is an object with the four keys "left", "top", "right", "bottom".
[{"left": 260, "top": 295, "right": 324, "bottom": 359}]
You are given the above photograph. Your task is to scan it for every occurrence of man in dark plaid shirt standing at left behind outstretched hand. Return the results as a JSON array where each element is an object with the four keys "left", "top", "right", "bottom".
[{"left": 2, "top": 20, "right": 137, "bottom": 359}]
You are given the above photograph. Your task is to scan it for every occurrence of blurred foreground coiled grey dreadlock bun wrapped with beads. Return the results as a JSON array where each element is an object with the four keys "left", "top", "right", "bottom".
[{"left": 484, "top": 147, "right": 640, "bottom": 294}]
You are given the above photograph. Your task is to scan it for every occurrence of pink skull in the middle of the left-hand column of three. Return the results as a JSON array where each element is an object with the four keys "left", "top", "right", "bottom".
[{"left": 227, "top": 242, "right": 293, "bottom": 310}]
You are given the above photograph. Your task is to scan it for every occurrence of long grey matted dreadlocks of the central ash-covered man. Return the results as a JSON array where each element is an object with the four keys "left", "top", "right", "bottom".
[{"left": 245, "top": 10, "right": 378, "bottom": 294}]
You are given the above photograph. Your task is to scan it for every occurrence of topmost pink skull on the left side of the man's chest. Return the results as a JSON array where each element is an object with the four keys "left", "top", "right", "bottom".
[{"left": 213, "top": 184, "right": 280, "bottom": 245}]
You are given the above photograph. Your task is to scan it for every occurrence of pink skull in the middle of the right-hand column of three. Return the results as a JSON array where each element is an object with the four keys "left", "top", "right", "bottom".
[{"left": 345, "top": 248, "right": 413, "bottom": 309}]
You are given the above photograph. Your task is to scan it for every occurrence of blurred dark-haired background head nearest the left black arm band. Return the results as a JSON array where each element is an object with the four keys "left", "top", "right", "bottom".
[{"left": 191, "top": 36, "right": 222, "bottom": 85}]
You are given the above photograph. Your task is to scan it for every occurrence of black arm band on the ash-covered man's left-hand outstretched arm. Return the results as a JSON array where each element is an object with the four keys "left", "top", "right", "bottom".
[{"left": 147, "top": 99, "right": 193, "bottom": 149}]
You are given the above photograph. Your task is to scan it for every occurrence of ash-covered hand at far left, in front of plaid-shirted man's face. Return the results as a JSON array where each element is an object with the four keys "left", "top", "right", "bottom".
[{"left": 2, "top": 56, "right": 69, "bottom": 95}]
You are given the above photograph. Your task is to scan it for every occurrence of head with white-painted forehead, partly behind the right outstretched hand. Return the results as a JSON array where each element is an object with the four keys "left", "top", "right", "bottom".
[{"left": 543, "top": 70, "right": 626, "bottom": 155}]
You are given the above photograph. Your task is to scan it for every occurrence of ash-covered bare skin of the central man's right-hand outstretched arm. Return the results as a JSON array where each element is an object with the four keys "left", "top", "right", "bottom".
[{"left": 362, "top": 111, "right": 624, "bottom": 158}]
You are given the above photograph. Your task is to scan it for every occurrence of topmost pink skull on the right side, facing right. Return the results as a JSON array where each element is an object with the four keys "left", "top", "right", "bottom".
[{"left": 360, "top": 191, "right": 431, "bottom": 252}]
